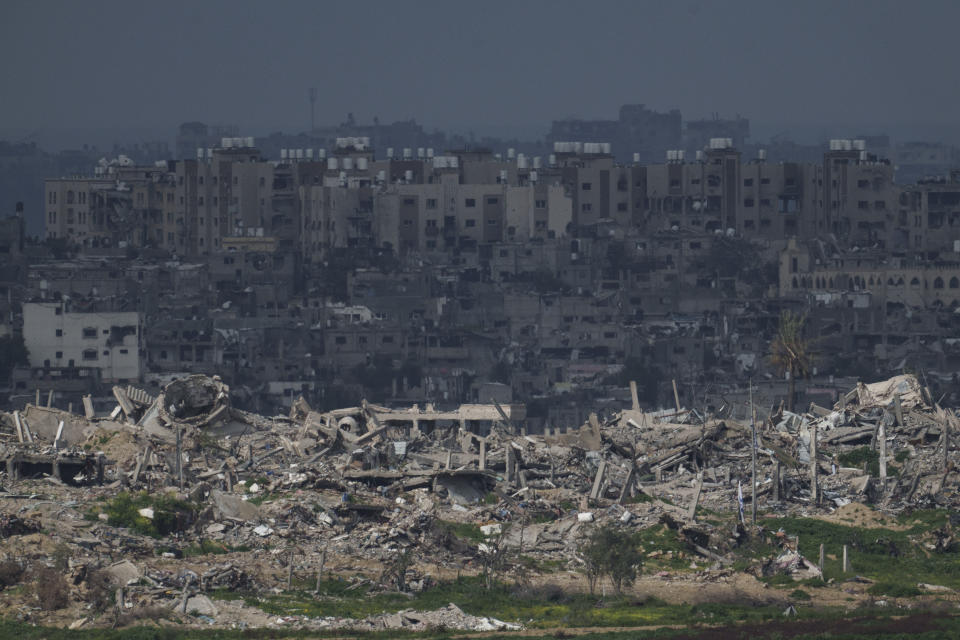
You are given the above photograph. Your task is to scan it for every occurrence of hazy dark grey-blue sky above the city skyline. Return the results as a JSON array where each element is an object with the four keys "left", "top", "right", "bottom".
[{"left": 0, "top": 0, "right": 960, "bottom": 136}]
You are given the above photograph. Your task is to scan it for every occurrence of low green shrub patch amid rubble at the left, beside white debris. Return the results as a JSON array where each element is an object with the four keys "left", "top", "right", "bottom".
[{"left": 87, "top": 491, "right": 195, "bottom": 538}]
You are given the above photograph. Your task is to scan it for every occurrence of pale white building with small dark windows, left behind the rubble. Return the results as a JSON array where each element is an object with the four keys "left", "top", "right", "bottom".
[{"left": 23, "top": 302, "right": 141, "bottom": 382}]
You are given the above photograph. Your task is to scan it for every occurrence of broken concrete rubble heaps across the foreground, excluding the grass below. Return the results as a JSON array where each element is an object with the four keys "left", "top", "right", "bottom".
[{"left": 0, "top": 376, "right": 958, "bottom": 630}]
